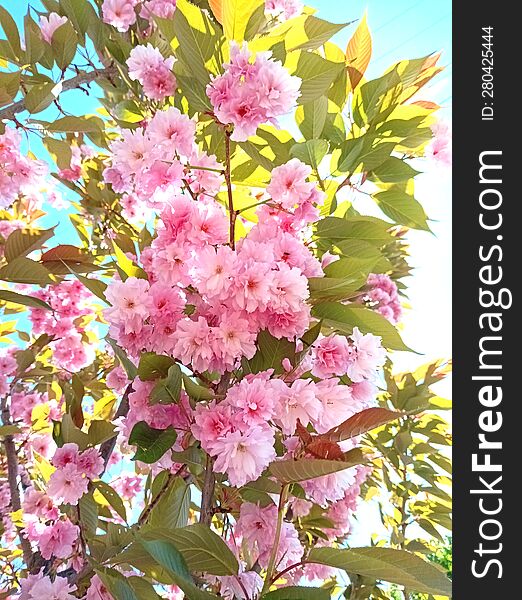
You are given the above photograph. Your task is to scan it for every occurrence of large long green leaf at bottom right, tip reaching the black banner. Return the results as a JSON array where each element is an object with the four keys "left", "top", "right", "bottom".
[{"left": 308, "top": 547, "right": 451, "bottom": 596}]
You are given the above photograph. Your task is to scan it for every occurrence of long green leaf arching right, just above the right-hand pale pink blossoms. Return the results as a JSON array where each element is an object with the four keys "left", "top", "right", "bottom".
[{"left": 312, "top": 302, "right": 411, "bottom": 351}]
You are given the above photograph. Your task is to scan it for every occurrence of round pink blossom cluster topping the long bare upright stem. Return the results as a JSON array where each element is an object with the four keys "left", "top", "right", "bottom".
[{"left": 207, "top": 42, "right": 301, "bottom": 142}]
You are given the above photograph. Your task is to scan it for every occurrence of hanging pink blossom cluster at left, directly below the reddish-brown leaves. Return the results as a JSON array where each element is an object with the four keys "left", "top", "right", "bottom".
[{"left": 29, "top": 280, "right": 94, "bottom": 372}]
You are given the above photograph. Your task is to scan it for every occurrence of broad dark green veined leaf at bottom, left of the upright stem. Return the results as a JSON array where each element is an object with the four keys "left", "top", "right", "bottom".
[{"left": 146, "top": 523, "right": 239, "bottom": 575}]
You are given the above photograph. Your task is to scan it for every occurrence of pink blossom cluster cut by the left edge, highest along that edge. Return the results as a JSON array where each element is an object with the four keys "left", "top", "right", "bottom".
[{"left": 0, "top": 127, "right": 47, "bottom": 208}]
